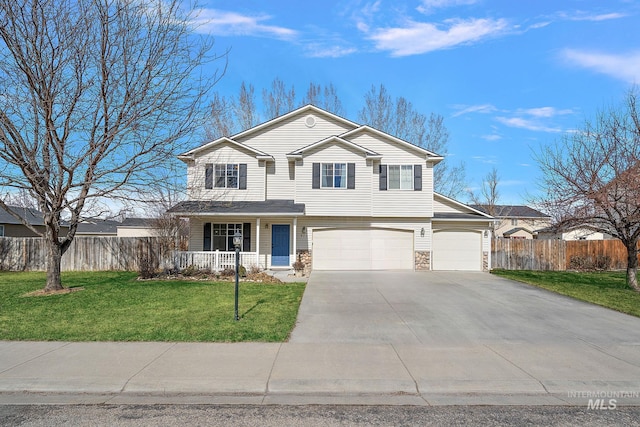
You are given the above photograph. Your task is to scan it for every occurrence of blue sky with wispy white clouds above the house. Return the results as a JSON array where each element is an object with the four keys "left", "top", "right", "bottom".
[{"left": 190, "top": 0, "right": 640, "bottom": 204}]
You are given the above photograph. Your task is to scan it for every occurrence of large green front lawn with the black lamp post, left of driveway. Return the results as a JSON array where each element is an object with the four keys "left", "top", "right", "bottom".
[{"left": 0, "top": 271, "right": 304, "bottom": 342}]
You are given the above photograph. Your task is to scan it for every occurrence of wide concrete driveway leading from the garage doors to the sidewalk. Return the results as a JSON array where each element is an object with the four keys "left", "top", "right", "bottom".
[{"left": 290, "top": 271, "right": 640, "bottom": 353}]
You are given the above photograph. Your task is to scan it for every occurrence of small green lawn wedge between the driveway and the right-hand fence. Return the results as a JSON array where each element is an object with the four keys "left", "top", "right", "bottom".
[{"left": 491, "top": 270, "right": 640, "bottom": 317}]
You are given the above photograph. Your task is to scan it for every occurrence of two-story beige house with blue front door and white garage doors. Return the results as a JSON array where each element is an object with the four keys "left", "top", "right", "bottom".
[{"left": 168, "top": 105, "right": 493, "bottom": 271}]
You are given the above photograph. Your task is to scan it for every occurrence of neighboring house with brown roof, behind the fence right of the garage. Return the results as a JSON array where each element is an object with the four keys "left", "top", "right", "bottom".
[{"left": 471, "top": 205, "right": 551, "bottom": 239}]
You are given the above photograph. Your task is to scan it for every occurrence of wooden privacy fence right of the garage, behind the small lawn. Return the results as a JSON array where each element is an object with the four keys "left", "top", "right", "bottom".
[{"left": 491, "top": 239, "right": 627, "bottom": 270}]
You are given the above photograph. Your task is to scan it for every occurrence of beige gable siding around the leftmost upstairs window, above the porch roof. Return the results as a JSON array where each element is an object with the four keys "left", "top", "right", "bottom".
[{"left": 187, "top": 143, "right": 265, "bottom": 201}]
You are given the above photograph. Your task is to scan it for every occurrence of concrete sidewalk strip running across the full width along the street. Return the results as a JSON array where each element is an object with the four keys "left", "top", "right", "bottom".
[{"left": 0, "top": 341, "right": 640, "bottom": 407}]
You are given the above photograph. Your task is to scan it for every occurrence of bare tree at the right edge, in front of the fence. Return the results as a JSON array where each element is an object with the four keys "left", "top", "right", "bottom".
[{"left": 536, "top": 89, "right": 640, "bottom": 292}]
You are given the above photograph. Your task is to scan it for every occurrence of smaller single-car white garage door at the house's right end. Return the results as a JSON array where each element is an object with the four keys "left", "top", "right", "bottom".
[{"left": 432, "top": 230, "right": 482, "bottom": 271}]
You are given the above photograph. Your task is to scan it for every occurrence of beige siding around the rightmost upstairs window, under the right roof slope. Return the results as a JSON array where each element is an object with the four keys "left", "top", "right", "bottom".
[{"left": 350, "top": 132, "right": 433, "bottom": 217}]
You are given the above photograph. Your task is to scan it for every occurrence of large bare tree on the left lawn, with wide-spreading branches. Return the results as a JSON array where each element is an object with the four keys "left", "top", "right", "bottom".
[{"left": 0, "top": 0, "right": 217, "bottom": 291}]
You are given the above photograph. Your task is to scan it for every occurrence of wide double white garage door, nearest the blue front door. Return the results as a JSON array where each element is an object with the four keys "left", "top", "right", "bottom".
[{"left": 312, "top": 228, "right": 413, "bottom": 270}]
